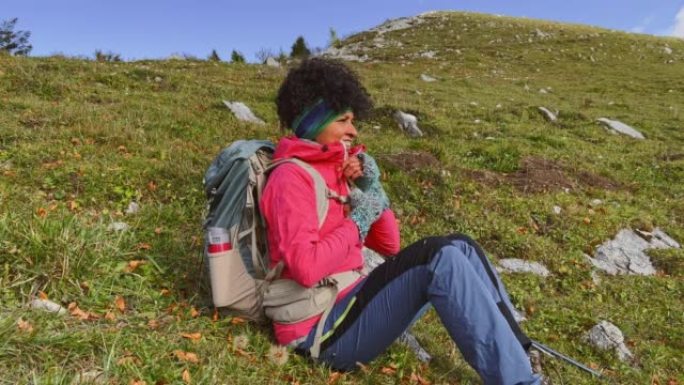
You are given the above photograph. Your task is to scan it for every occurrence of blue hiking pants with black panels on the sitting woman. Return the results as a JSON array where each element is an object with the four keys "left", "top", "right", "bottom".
[{"left": 296, "top": 235, "right": 540, "bottom": 385}]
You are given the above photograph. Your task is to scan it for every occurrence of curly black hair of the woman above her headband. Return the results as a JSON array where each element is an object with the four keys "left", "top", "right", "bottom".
[{"left": 276, "top": 58, "right": 373, "bottom": 129}]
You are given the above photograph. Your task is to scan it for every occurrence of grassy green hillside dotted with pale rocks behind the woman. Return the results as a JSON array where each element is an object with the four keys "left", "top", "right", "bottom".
[{"left": 0, "top": 13, "right": 684, "bottom": 384}]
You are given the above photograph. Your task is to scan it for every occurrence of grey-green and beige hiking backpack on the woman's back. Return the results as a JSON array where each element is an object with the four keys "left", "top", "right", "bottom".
[{"left": 200, "top": 140, "right": 337, "bottom": 321}]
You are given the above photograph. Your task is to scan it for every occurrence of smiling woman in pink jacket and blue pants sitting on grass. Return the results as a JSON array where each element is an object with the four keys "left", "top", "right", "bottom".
[{"left": 260, "top": 59, "right": 540, "bottom": 384}]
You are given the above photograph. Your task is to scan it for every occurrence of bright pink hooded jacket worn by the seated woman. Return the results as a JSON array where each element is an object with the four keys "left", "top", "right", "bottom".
[{"left": 260, "top": 136, "right": 399, "bottom": 345}]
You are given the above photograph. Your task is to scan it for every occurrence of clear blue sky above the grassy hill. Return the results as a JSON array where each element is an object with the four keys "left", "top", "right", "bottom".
[{"left": 0, "top": 0, "right": 684, "bottom": 61}]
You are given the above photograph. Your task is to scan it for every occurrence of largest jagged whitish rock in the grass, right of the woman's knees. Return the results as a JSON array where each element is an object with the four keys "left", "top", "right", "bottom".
[{"left": 587, "top": 228, "right": 681, "bottom": 275}]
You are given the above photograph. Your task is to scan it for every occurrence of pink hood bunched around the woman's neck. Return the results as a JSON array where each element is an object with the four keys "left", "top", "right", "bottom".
[{"left": 273, "top": 135, "right": 366, "bottom": 164}]
